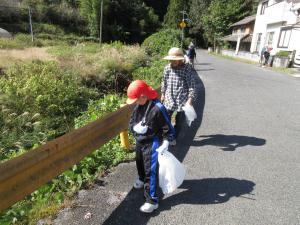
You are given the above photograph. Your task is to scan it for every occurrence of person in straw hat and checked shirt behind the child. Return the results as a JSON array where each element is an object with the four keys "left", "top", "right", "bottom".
[{"left": 161, "top": 48, "right": 197, "bottom": 144}]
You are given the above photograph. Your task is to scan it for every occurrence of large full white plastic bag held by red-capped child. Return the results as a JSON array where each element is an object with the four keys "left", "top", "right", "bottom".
[{"left": 158, "top": 151, "right": 185, "bottom": 194}]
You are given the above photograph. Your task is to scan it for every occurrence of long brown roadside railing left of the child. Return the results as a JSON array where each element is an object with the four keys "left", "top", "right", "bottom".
[{"left": 0, "top": 105, "right": 133, "bottom": 211}]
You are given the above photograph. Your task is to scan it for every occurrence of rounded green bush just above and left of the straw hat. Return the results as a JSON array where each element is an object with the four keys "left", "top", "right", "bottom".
[{"left": 142, "top": 29, "right": 180, "bottom": 57}]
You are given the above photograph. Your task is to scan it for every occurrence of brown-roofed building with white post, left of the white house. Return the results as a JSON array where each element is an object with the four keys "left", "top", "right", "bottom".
[{"left": 222, "top": 15, "right": 256, "bottom": 54}]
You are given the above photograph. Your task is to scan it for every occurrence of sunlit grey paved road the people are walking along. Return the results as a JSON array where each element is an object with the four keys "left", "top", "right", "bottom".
[{"left": 55, "top": 51, "right": 300, "bottom": 225}]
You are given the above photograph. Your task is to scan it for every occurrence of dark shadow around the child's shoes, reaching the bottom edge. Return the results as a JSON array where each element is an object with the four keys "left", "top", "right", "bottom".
[{"left": 103, "top": 178, "right": 255, "bottom": 225}]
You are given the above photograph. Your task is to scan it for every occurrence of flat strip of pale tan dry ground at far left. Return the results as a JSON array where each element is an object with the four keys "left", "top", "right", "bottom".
[{"left": 0, "top": 48, "right": 55, "bottom": 60}]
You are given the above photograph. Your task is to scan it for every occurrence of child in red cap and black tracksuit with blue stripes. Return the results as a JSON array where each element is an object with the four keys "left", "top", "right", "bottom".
[{"left": 126, "top": 80, "right": 175, "bottom": 213}]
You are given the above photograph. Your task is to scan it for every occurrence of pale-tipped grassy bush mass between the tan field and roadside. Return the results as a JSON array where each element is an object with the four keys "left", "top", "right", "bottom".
[{"left": 50, "top": 42, "right": 148, "bottom": 93}]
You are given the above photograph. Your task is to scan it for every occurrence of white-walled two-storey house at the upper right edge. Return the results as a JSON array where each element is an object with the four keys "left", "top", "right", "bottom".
[{"left": 250, "top": 0, "right": 300, "bottom": 66}]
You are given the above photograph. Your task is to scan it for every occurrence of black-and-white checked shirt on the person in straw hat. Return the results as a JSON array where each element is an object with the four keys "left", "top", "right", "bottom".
[{"left": 161, "top": 64, "right": 197, "bottom": 112}]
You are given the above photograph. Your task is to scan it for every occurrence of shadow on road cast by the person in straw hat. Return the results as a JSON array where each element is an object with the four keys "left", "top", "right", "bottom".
[{"left": 192, "top": 134, "right": 266, "bottom": 151}]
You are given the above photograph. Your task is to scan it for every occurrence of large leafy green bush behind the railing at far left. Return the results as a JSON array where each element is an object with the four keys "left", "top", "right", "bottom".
[{"left": 0, "top": 61, "right": 97, "bottom": 148}]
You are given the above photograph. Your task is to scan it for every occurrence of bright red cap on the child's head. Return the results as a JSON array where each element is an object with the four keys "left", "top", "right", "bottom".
[{"left": 126, "top": 80, "right": 158, "bottom": 104}]
